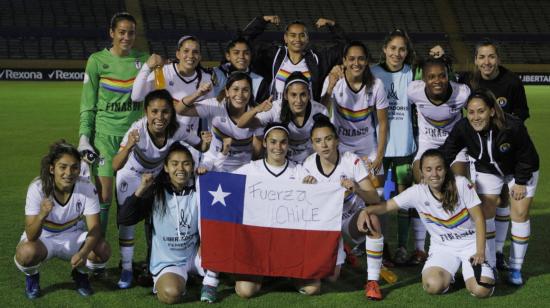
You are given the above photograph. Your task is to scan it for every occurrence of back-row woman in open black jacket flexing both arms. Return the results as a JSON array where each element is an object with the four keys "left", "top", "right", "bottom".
[{"left": 243, "top": 16, "right": 347, "bottom": 101}]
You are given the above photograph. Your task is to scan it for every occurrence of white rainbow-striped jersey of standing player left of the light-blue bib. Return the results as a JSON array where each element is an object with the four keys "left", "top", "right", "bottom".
[{"left": 322, "top": 77, "right": 388, "bottom": 156}]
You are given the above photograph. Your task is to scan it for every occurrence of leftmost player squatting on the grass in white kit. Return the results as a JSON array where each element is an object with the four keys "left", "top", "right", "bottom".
[{"left": 14, "top": 140, "right": 111, "bottom": 299}]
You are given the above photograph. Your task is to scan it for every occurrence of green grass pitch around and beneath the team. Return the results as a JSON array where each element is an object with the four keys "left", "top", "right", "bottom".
[{"left": 0, "top": 82, "right": 550, "bottom": 307}]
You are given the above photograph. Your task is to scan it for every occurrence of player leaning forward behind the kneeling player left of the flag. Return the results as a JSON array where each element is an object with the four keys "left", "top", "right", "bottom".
[{"left": 113, "top": 90, "right": 209, "bottom": 289}]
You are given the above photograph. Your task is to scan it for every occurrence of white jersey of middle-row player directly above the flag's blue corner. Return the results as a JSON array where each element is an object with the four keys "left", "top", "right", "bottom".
[{"left": 195, "top": 98, "right": 255, "bottom": 171}]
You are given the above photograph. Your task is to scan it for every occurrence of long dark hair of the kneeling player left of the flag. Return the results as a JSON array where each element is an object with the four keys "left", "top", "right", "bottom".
[{"left": 152, "top": 142, "right": 195, "bottom": 216}]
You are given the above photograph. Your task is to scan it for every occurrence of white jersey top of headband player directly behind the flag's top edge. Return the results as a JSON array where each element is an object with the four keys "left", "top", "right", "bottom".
[{"left": 233, "top": 159, "right": 308, "bottom": 182}]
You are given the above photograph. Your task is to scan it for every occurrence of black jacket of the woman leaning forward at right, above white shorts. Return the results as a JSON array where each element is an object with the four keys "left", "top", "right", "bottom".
[{"left": 440, "top": 114, "right": 539, "bottom": 185}]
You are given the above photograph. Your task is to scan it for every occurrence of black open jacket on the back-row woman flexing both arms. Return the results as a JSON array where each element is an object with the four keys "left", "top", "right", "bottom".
[{"left": 242, "top": 16, "right": 349, "bottom": 102}]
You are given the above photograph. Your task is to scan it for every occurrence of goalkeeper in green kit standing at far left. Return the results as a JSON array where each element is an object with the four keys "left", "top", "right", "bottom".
[{"left": 78, "top": 13, "right": 147, "bottom": 235}]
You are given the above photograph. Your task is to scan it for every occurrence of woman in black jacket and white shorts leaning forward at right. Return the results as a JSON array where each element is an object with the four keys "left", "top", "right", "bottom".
[{"left": 441, "top": 89, "right": 539, "bottom": 285}]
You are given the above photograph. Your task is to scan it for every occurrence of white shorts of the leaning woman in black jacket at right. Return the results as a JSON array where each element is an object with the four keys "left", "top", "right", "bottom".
[{"left": 475, "top": 171, "right": 539, "bottom": 198}]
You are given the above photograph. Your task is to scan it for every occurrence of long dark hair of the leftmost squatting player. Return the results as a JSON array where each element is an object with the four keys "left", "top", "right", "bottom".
[{"left": 40, "top": 139, "right": 81, "bottom": 197}]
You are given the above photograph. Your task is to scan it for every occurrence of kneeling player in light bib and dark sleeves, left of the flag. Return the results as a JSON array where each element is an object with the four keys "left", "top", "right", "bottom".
[{"left": 118, "top": 142, "right": 218, "bottom": 304}]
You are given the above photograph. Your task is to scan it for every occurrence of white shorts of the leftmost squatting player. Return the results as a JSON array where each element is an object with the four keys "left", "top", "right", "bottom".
[{"left": 20, "top": 229, "right": 88, "bottom": 260}]
